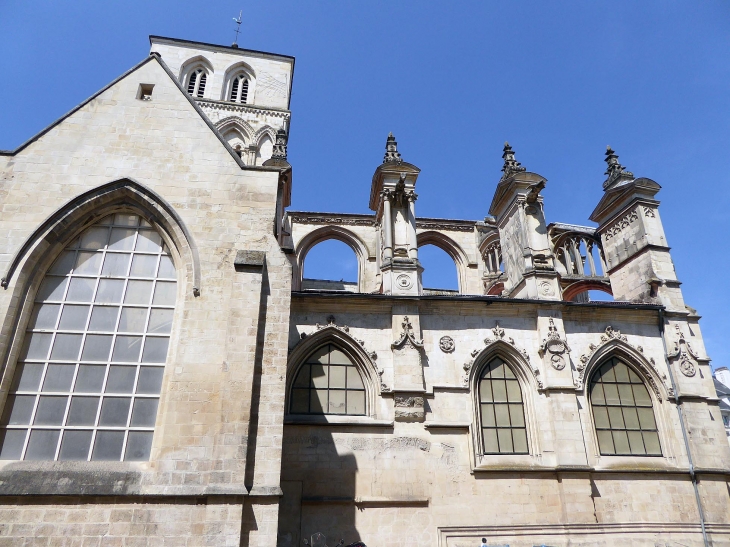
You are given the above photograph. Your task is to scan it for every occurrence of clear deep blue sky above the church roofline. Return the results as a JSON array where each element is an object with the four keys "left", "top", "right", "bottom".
[{"left": 0, "top": 0, "right": 730, "bottom": 366}]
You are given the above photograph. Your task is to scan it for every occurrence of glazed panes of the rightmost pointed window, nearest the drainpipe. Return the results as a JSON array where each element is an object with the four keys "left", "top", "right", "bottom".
[{"left": 590, "top": 357, "right": 662, "bottom": 456}]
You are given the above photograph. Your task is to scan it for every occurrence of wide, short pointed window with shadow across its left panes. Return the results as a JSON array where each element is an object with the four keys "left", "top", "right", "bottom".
[{"left": 289, "top": 344, "right": 366, "bottom": 416}]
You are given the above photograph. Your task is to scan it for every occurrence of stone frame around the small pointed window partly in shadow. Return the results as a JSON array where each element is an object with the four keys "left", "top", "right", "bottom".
[{"left": 285, "top": 323, "right": 384, "bottom": 422}]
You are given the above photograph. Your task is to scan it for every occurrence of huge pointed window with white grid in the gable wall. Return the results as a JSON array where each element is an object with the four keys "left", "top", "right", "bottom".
[{"left": 0, "top": 213, "right": 176, "bottom": 461}]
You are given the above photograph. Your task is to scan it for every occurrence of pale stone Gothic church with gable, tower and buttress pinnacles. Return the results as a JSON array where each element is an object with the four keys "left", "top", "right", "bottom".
[{"left": 0, "top": 36, "right": 730, "bottom": 547}]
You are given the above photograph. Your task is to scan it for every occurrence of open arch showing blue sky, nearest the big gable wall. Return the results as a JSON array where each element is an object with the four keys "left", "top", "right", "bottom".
[{"left": 302, "top": 239, "right": 359, "bottom": 292}]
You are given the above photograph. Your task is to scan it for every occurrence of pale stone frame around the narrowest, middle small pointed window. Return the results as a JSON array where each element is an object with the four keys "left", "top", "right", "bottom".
[{"left": 467, "top": 340, "right": 541, "bottom": 470}]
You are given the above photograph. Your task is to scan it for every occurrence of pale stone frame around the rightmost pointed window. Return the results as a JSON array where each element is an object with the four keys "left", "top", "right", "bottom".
[{"left": 578, "top": 338, "right": 681, "bottom": 469}]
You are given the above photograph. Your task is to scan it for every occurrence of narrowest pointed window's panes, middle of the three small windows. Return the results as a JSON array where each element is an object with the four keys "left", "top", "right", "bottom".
[{"left": 479, "top": 357, "right": 528, "bottom": 454}]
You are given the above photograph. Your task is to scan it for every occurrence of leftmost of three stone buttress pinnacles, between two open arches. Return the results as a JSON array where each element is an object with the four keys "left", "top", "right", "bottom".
[{"left": 370, "top": 133, "right": 423, "bottom": 296}]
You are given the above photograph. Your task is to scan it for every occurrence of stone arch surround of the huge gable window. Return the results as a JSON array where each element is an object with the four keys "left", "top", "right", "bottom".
[{"left": 0, "top": 209, "right": 183, "bottom": 461}]
